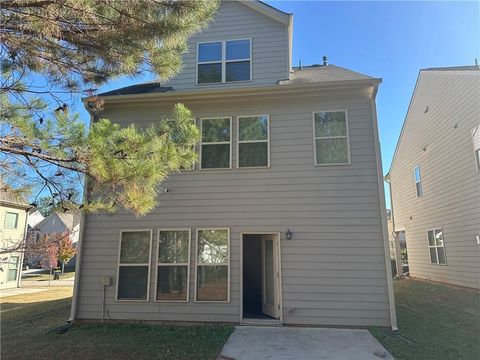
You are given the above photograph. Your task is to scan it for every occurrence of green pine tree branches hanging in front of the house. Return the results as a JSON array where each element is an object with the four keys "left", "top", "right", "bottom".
[{"left": 0, "top": 0, "right": 219, "bottom": 215}]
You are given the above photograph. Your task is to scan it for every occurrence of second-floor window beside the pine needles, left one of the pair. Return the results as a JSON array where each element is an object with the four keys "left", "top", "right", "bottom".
[{"left": 200, "top": 117, "right": 232, "bottom": 169}]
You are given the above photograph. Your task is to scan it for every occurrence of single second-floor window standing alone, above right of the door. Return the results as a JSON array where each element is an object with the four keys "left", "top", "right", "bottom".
[{"left": 313, "top": 110, "right": 350, "bottom": 165}]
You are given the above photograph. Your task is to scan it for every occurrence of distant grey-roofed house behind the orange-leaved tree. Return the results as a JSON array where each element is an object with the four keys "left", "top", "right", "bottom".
[{"left": 28, "top": 211, "right": 81, "bottom": 267}]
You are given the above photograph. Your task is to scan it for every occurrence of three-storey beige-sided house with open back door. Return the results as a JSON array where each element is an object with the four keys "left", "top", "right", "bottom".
[{"left": 71, "top": 1, "right": 396, "bottom": 328}]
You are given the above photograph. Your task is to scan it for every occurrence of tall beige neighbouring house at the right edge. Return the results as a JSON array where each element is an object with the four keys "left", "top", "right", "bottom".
[{"left": 386, "top": 66, "right": 480, "bottom": 288}]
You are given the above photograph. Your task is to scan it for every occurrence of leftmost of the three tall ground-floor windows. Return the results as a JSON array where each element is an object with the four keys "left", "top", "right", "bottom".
[{"left": 117, "top": 230, "right": 152, "bottom": 301}]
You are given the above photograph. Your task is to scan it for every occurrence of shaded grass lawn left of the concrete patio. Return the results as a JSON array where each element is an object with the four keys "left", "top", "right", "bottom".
[{"left": 0, "top": 287, "right": 233, "bottom": 360}]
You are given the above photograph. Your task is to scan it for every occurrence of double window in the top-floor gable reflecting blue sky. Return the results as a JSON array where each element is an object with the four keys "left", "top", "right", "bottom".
[{"left": 197, "top": 39, "right": 252, "bottom": 84}]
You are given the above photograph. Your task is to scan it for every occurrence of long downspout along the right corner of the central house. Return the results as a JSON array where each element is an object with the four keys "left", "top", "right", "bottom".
[{"left": 370, "top": 85, "right": 398, "bottom": 331}]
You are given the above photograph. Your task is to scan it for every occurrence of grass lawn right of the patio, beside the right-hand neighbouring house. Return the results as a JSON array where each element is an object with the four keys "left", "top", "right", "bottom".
[{"left": 370, "top": 279, "right": 480, "bottom": 360}]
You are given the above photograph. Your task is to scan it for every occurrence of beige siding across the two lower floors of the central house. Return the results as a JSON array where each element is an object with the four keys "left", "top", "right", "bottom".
[{"left": 77, "top": 88, "right": 390, "bottom": 326}]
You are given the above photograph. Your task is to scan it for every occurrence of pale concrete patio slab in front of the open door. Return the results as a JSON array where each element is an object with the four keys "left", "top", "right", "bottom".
[{"left": 218, "top": 326, "right": 393, "bottom": 360}]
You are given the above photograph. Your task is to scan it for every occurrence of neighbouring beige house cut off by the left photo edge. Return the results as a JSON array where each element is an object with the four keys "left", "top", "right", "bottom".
[{"left": 0, "top": 189, "right": 30, "bottom": 289}]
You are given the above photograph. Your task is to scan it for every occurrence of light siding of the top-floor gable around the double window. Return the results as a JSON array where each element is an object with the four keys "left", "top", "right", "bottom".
[{"left": 162, "top": 1, "right": 289, "bottom": 90}]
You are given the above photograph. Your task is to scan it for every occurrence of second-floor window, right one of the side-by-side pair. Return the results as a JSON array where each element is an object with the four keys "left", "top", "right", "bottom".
[{"left": 237, "top": 115, "right": 270, "bottom": 167}]
